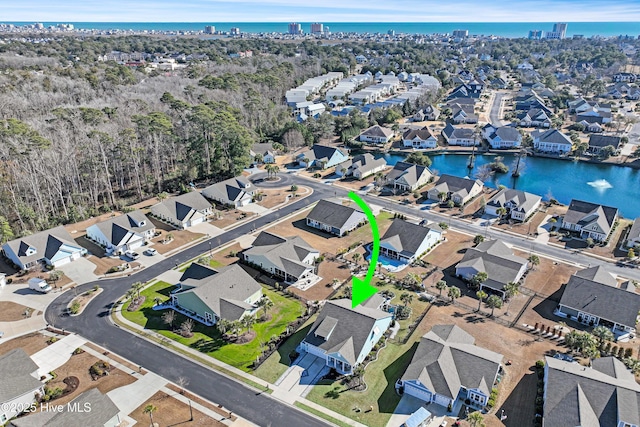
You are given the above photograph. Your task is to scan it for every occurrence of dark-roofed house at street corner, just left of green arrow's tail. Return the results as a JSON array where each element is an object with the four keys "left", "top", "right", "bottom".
[{"left": 306, "top": 199, "right": 367, "bottom": 237}]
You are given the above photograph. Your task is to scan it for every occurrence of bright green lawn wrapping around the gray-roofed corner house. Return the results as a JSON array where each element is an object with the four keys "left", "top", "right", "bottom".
[{"left": 122, "top": 282, "right": 304, "bottom": 372}]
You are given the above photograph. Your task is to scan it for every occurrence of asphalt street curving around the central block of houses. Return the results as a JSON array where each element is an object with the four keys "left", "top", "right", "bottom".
[{"left": 45, "top": 174, "right": 640, "bottom": 427}]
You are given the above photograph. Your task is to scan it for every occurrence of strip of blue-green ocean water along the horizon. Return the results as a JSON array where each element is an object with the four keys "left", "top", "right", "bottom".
[{"left": 3, "top": 22, "right": 640, "bottom": 37}]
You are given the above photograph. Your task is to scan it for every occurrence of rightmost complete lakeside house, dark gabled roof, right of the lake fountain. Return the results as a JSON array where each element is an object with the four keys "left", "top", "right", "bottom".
[{"left": 562, "top": 199, "right": 618, "bottom": 242}]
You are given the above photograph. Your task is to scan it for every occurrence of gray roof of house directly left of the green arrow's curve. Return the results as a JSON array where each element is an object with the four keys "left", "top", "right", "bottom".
[{"left": 244, "top": 231, "right": 318, "bottom": 277}]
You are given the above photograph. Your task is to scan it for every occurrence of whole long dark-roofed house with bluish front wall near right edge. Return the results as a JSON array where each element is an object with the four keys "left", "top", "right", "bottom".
[{"left": 555, "top": 266, "right": 640, "bottom": 338}]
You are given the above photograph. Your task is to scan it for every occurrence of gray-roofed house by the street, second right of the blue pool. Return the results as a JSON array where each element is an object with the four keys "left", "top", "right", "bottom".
[{"left": 456, "top": 240, "right": 529, "bottom": 298}]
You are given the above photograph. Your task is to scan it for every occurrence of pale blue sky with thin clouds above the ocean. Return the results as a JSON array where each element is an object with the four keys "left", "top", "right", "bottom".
[{"left": 0, "top": 0, "right": 640, "bottom": 22}]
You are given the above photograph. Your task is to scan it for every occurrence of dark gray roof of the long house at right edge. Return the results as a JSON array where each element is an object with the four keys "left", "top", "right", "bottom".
[{"left": 560, "top": 274, "right": 640, "bottom": 327}]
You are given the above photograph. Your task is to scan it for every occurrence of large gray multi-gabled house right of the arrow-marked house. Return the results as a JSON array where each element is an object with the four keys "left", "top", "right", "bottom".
[{"left": 396, "top": 325, "right": 503, "bottom": 409}]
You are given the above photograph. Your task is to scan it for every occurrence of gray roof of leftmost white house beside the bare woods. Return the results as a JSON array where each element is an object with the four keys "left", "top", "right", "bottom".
[{"left": 5, "top": 225, "right": 80, "bottom": 264}]
